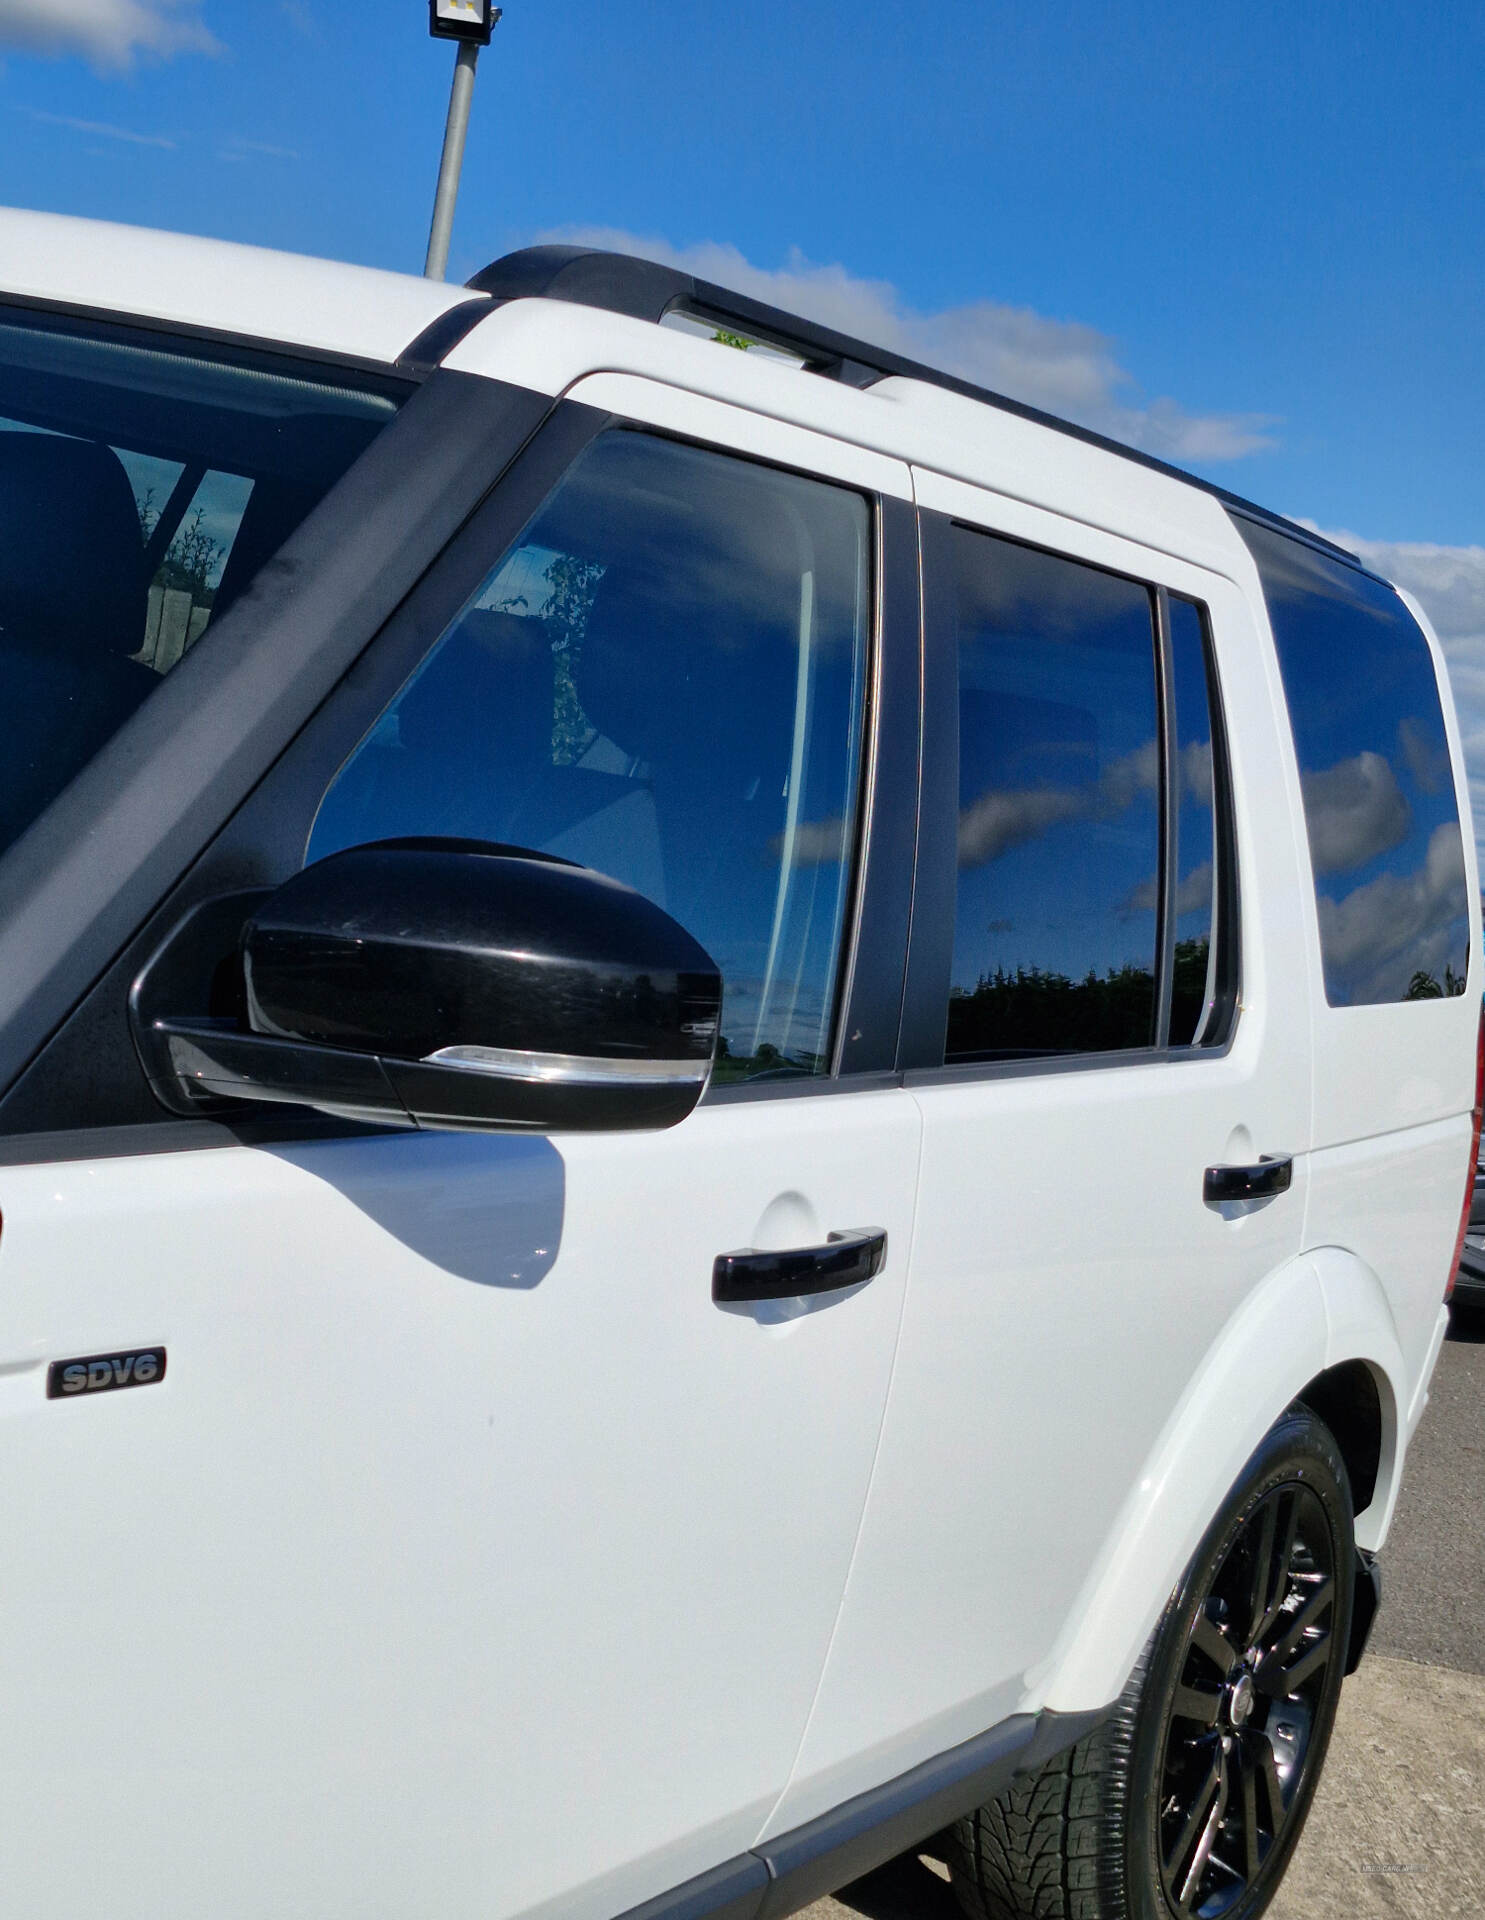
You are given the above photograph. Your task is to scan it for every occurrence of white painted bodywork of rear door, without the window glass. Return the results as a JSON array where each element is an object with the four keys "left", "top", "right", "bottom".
[{"left": 753, "top": 474, "right": 1308, "bottom": 1832}]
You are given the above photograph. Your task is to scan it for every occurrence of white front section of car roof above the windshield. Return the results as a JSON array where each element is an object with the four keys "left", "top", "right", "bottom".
[{"left": 0, "top": 207, "right": 478, "bottom": 361}]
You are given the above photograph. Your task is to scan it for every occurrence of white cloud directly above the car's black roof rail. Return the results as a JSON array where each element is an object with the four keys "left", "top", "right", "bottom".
[{"left": 542, "top": 227, "right": 1274, "bottom": 463}]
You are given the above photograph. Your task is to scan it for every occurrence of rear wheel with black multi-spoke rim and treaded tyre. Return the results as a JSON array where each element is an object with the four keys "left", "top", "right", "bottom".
[{"left": 947, "top": 1405, "right": 1356, "bottom": 1920}]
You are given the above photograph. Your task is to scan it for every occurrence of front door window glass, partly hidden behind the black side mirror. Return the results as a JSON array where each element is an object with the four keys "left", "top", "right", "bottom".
[{"left": 309, "top": 430, "right": 870, "bottom": 1079}]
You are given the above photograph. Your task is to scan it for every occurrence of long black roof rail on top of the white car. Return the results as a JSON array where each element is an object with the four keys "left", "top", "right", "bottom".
[{"left": 465, "top": 246, "right": 1366, "bottom": 570}]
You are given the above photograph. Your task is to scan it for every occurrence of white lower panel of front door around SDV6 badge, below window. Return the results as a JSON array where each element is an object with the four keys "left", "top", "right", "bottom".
[{"left": 0, "top": 1092, "right": 918, "bottom": 1920}]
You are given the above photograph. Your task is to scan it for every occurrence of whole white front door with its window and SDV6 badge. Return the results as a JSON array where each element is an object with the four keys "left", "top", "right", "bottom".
[{"left": 0, "top": 382, "right": 922, "bottom": 1920}]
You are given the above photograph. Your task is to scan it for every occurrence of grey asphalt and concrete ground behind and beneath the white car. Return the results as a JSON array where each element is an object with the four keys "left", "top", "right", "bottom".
[{"left": 805, "top": 1313, "right": 1485, "bottom": 1920}]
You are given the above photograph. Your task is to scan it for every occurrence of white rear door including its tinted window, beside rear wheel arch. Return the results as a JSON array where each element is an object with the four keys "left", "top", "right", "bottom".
[{"left": 764, "top": 474, "right": 1310, "bottom": 1824}]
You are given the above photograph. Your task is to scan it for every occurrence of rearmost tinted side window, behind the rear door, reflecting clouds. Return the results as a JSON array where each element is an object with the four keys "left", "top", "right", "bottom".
[{"left": 1237, "top": 520, "right": 1470, "bottom": 1006}]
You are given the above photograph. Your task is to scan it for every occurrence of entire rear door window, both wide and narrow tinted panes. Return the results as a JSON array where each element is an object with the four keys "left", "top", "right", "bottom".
[{"left": 932, "top": 524, "right": 1237, "bottom": 1066}]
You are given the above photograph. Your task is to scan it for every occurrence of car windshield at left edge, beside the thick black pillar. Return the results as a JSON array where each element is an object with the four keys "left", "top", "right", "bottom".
[{"left": 0, "top": 313, "right": 405, "bottom": 852}]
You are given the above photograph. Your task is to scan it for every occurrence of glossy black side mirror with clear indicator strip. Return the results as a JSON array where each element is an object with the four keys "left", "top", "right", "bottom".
[{"left": 131, "top": 841, "right": 722, "bottom": 1133}]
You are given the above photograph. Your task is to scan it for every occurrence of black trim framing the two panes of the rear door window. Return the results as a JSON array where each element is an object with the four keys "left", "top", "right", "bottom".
[{"left": 897, "top": 509, "right": 1243, "bottom": 1087}]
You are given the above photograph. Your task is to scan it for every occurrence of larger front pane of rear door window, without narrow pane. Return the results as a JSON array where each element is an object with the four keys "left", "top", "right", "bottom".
[{"left": 945, "top": 528, "right": 1160, "bottom": 1062}]
